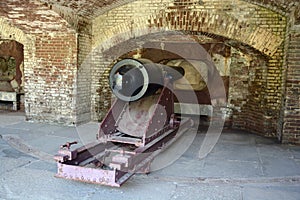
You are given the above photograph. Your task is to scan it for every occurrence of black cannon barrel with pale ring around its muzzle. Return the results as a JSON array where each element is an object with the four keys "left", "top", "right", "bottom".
[{"left": 109, "top": 59, "right": 184, "bottom": 102}]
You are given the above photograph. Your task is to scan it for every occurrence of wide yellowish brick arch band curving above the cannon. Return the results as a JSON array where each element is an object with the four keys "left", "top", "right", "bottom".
[{"left": 96, "top": 11, "right": 283, "bottom": 56}]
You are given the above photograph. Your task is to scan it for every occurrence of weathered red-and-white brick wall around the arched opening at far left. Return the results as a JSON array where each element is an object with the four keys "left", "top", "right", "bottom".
[{"left": 0, "top": 0, "right": 77, "bottom": 124}]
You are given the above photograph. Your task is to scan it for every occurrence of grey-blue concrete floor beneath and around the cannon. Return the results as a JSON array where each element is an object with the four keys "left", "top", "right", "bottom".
[{"left": 0, "top": 112, "right": 300, "bottom": 200}]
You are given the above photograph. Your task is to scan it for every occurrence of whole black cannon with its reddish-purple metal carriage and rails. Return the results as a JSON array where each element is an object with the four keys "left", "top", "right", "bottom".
[{"left": 54, "top": 58, "right": 193, "bottom": 187}]
